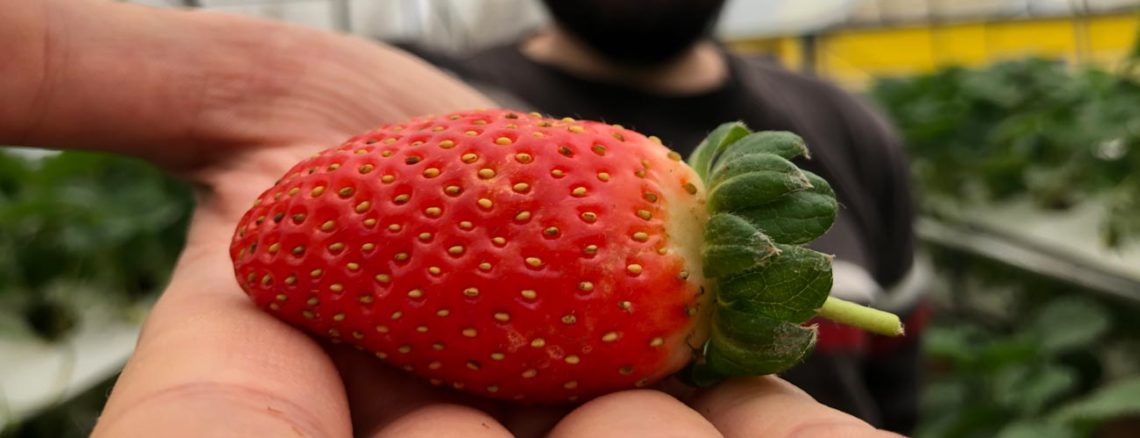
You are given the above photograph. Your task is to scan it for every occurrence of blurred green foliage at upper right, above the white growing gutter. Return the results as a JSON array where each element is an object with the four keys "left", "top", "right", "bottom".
[{"left": 871, "top": 58, "right": 1140, "bottom": 246}]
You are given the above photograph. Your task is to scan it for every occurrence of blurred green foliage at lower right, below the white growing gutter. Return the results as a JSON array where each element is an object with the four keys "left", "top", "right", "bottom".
[{"left": 915, "top": 290, "right": 1140, "bottom": 438}]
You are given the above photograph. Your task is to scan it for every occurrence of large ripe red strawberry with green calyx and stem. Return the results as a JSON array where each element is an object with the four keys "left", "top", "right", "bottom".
[{"left": 230, "top": 110, "right": 897, "bottom": 403}]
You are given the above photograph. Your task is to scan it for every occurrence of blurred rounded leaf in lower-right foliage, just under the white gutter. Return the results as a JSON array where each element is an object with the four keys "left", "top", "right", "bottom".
[{"left": 1029, "top": 295, "right": 1110, "bottom": 354}]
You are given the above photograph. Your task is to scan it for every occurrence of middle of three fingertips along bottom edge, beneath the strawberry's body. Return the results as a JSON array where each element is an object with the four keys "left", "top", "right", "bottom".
[{"left": 549, "top": 390, "right": 720, "bottom": 438}]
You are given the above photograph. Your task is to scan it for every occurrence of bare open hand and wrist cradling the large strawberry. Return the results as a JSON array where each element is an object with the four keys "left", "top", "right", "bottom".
[{"left": 0, "top": 0, "right": 890, "bottom": 437}]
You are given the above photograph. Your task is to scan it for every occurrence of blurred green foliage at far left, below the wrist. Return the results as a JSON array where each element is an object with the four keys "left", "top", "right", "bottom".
[{"left": 0, "top": 148, "right": 194, "bottom": 339}]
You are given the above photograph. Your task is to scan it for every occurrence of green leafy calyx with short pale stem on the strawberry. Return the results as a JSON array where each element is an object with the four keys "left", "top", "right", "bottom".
[{"left": 684, "top": 122, "right": 903, "bottom": 386}]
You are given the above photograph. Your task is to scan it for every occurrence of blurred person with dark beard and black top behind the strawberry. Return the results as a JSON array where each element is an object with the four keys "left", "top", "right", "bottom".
[{"left": 407, "top": 0, "right": 926, "bottom": 432}]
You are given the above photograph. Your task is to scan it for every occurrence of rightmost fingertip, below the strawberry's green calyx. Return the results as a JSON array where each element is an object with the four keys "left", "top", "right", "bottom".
[{"left": 693, "top": 376, "right": 897, "bottom": 438}]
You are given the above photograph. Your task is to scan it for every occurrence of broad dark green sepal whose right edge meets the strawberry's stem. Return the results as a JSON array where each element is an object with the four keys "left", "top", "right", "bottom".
[{"left": 716, "top": 246, "right": 831, "bottom": 323}]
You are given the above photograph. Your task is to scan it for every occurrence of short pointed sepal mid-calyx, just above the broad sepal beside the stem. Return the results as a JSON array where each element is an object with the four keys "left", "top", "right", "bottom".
[{"left": 703, "top": 213, "right": 780, "bottom": 278}]
